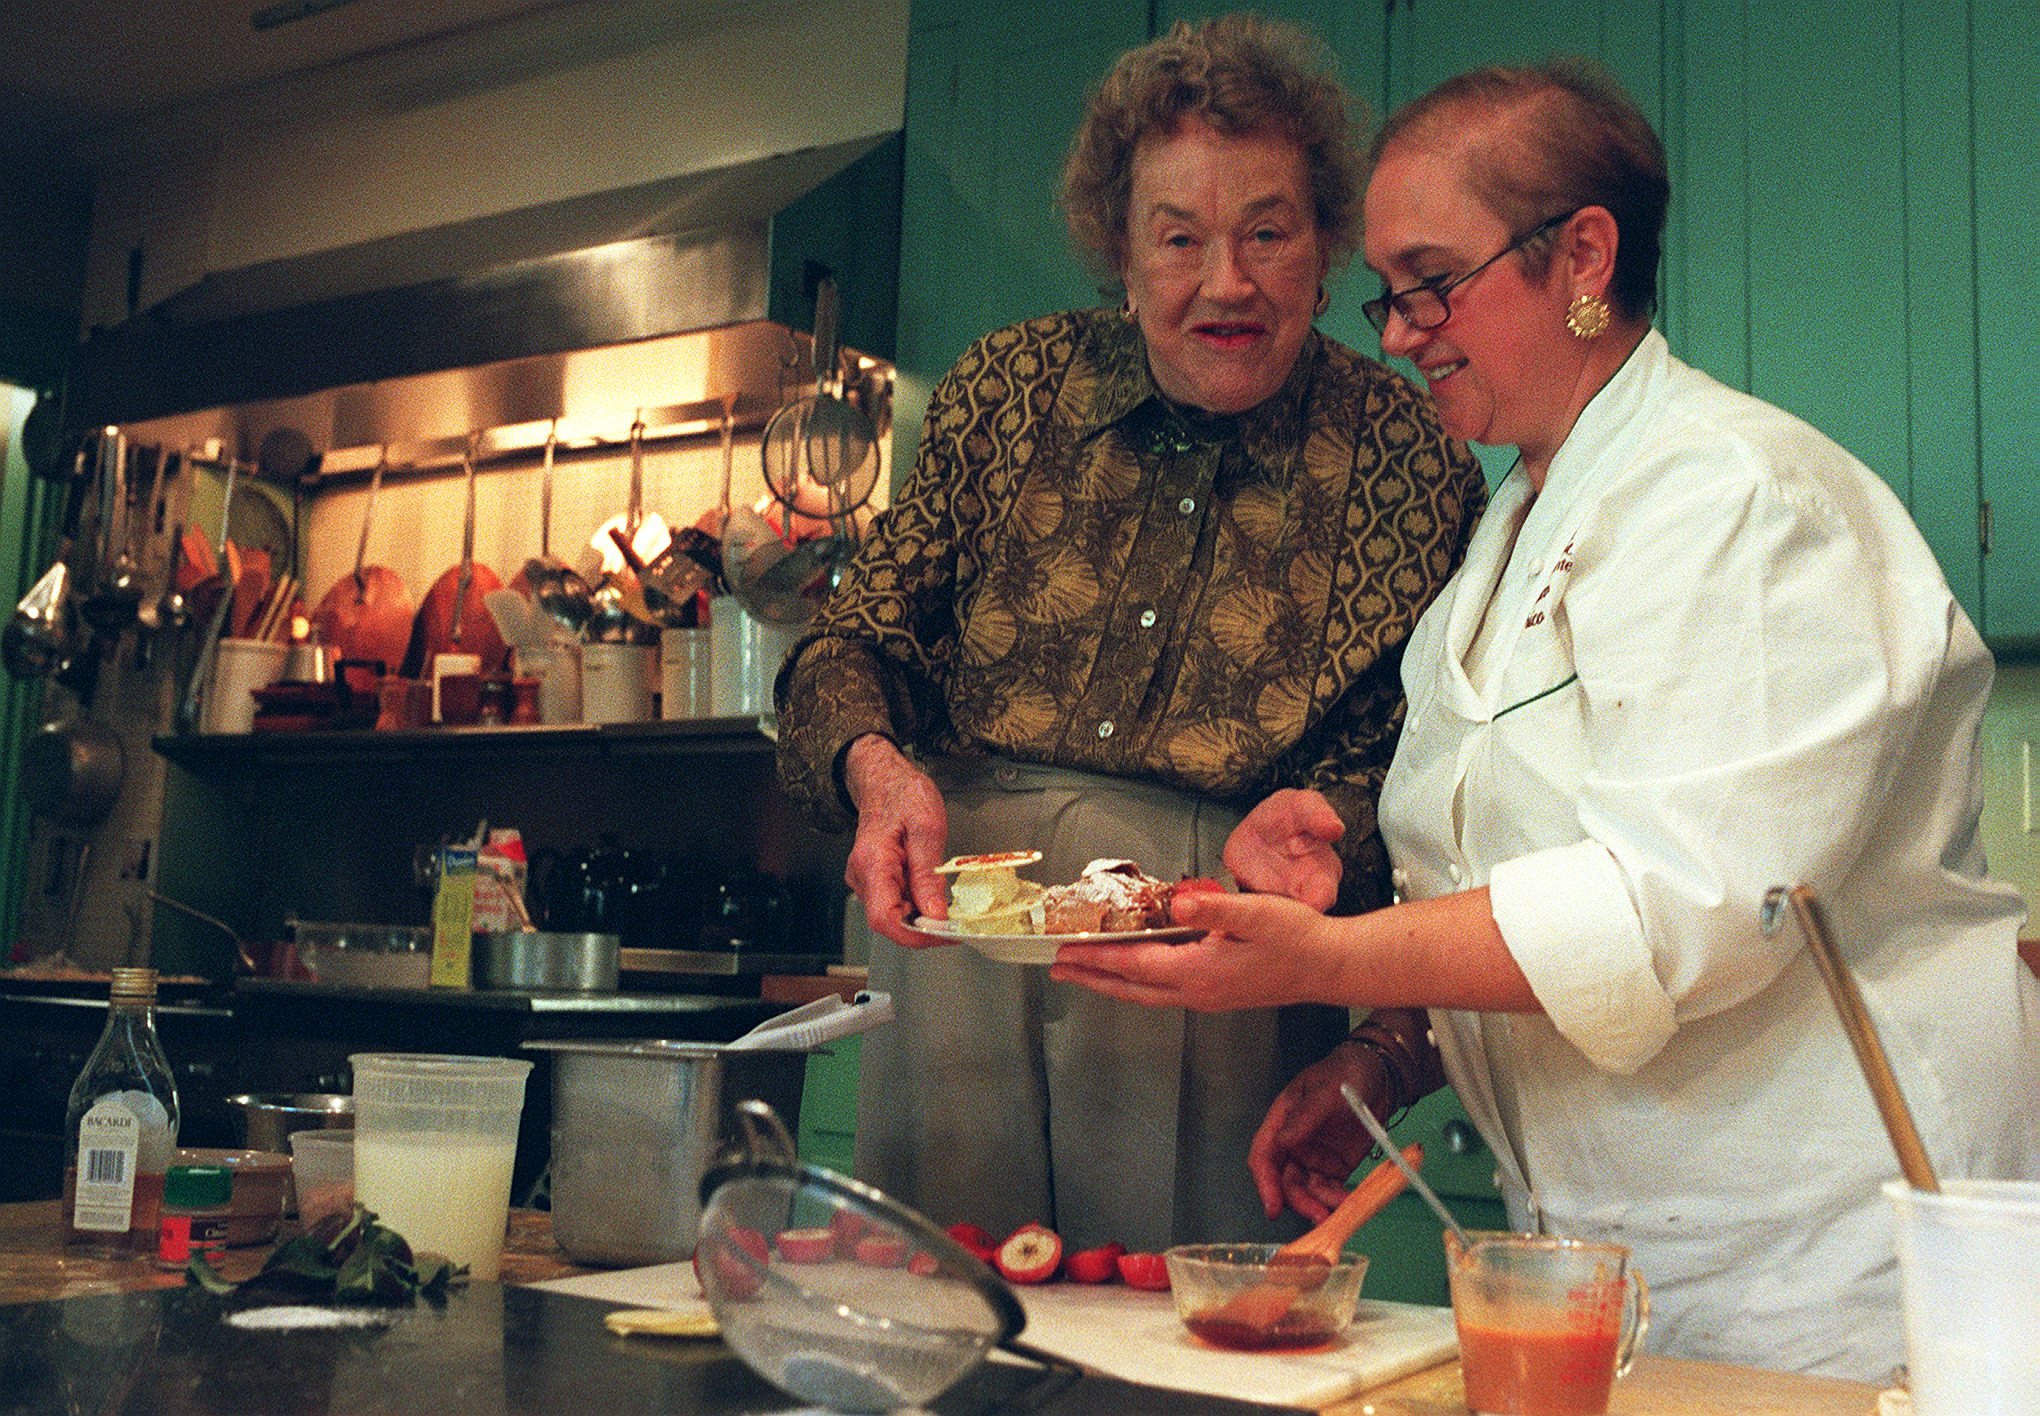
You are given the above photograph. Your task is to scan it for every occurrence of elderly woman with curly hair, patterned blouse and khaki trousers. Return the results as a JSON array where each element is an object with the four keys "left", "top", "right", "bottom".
[{"left": 777, "top": 16, "right": 1485, "bottom": 1247}]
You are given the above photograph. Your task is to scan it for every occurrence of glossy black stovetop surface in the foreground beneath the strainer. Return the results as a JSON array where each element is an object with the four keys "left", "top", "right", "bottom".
[{"left": 0, "top": 1283, "right": 1305, "bottom": 1416}]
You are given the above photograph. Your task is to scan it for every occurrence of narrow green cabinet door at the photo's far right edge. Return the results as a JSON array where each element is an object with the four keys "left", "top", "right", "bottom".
[{"left": 1973, "top": 0, "right": 2040, "bottom": 647}]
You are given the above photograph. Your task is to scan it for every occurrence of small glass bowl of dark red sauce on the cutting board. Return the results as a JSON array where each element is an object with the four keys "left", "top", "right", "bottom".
[{"left": 1163, "top": 1245, "right": 1367, "bottom": 1353}]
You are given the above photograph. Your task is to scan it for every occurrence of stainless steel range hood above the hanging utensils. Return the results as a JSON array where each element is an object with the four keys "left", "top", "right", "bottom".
[{"left": 65, "top": 135, "right": 900, "bottom": 447}]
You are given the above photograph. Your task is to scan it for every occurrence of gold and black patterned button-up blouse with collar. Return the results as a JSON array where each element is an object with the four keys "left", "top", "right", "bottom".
[{"left": 777, "top": 310, "right": 1485, "bottom": 908}]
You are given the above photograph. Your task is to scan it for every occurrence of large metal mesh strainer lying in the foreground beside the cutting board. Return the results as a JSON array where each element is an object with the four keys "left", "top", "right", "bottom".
[{"left": 694, "top": 1102, "right": 1077, "bottom": 1412}]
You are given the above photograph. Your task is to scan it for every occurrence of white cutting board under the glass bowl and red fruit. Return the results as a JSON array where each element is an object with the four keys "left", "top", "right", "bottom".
[{"left": 532, "top": 1263, "right": 1459, "bottom": 1408}]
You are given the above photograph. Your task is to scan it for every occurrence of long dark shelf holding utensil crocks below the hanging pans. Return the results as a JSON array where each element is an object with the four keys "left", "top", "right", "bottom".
[{"left": 151, "top": 716, "right": 777, "bottom": 771}]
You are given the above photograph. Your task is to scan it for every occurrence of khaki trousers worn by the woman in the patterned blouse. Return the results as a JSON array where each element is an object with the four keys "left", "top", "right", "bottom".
[{"left": 851, "top": 759, "right": 1346, "bottom": 1251}]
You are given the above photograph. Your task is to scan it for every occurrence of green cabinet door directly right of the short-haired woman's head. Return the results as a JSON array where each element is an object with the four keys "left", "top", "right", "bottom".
[{"left": 1673, "top": 0, "right": 1911, "bottom": 496}]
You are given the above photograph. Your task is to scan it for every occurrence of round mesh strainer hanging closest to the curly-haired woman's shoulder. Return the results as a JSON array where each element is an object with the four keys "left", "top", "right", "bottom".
[{"left": 759, "top": 275, "right": 879, "bottom": 535}]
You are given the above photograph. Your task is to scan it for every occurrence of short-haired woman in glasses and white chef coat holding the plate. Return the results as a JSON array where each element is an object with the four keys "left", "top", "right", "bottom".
[{"left": 1053, "top": 63, "right": 2040, "bottom": 1379}]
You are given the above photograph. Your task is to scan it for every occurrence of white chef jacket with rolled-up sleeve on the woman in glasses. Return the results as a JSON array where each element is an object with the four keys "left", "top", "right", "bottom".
[{"left": 1381, "top": 331, "right": 2040, "bottom": 1381}]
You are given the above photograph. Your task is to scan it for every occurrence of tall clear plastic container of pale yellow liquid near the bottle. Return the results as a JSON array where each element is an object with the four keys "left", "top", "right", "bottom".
[{"left": 349, "top": 1053, "right": 530, "bottom": 1279}]
